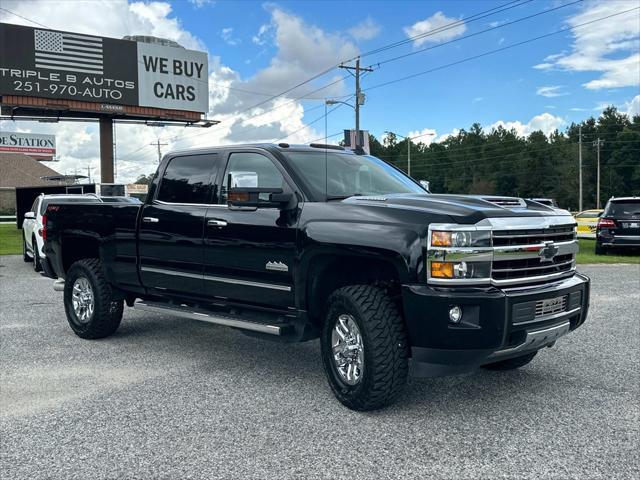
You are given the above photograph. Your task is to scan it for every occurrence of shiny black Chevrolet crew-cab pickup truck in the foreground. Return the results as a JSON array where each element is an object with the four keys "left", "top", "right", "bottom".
[{"left": 43, "top": 144, "right": 589, "bottom": 410}]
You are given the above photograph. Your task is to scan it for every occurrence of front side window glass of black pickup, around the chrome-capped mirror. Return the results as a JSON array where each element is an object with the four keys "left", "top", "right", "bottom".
[{"left": 221, "top": 152, "right": 285, "bottom": 203}]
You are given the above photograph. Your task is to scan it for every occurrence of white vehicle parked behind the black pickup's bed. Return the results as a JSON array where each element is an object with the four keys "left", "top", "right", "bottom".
[{"left": 22, "top": 193, "right": 101, "bottom": 272}]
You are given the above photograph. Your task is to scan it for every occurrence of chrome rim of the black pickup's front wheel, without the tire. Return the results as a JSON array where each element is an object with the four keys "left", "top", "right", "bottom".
[{"left": 331, "top": 314, "right": 364, "bottom": 385}]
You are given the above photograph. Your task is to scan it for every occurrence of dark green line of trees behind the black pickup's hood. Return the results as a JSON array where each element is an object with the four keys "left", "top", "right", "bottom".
[{"left": 369, "top": 107, "right": 640, "bottom": 210}]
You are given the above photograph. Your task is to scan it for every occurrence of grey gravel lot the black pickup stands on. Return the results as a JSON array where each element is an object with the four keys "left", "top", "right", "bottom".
[{"left": 0, "top": 257, "right": 640, "bottom": 479}]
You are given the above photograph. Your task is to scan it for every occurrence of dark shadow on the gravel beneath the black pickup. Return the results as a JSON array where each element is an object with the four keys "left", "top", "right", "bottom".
[{"left": 109, "top": 313, "right": 571, "bottom": 415}]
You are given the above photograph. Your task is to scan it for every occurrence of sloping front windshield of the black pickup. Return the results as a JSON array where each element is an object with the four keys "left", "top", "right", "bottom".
[{"left": 285, "top": 151, "right": 426, "bottom": 200}]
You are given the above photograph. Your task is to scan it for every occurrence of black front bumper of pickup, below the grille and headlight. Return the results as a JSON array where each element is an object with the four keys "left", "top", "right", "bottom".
[{"left": 402, "top": 274, "right": 589, "bottom": 376}]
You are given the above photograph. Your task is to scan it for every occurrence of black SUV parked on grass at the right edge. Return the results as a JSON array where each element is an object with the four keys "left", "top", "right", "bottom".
[{"left": 596, "top": 196, "right": 640, "bottom": 255}]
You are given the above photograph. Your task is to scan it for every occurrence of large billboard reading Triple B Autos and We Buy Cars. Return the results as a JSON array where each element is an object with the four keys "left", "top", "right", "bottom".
[{"left": 0, "top": 23, "right": 209, "bottom": 113}]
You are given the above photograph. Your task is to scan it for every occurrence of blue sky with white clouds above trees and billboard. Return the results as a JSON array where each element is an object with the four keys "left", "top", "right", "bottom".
[{"left": 0, "top": 0, "right": 640, "bottom": 178}]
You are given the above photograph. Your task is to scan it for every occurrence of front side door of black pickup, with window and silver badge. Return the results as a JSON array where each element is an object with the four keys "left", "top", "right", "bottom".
[{"left": 204, "top": 151, "right": 297, "bottom": 308}]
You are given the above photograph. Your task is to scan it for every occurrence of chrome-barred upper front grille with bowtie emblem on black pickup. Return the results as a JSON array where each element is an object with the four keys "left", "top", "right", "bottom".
[{"left": 491, "top": 225, "right": 578, "bottom": 285}]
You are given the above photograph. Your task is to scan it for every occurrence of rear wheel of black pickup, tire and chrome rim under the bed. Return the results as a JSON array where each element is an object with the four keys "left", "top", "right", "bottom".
[{"left": 64, "top": 258, "right": 124, "bottom": 339}]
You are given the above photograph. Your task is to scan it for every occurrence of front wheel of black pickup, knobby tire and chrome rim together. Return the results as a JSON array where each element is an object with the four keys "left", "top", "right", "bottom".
[{"left": 320, "top": 285, "right": 409, "bottom": 411}]
